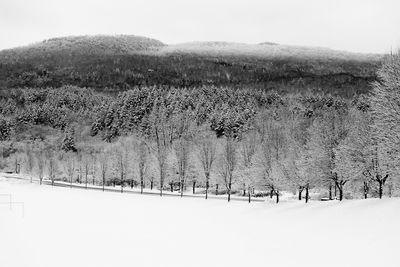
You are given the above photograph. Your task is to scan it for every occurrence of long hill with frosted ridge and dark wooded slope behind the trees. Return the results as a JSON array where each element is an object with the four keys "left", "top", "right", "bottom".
[{"left": 0, "top": 35, "right": 383, "bottom": 97}]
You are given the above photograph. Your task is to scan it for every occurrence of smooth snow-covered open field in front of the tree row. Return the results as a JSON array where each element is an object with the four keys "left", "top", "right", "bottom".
[{"left": 0, "top": 178, "right": 400, "bottom": 267}]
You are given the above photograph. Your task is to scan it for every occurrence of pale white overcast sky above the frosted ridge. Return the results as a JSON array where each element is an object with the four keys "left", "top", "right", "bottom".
[{"left": 0, "top": 0, "right": 400, "bottom": 53}]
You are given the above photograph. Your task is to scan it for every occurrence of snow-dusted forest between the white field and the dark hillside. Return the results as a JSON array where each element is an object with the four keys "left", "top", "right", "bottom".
[{"left": 0, "top": 55, "right": 400, "bottom": 203}]
